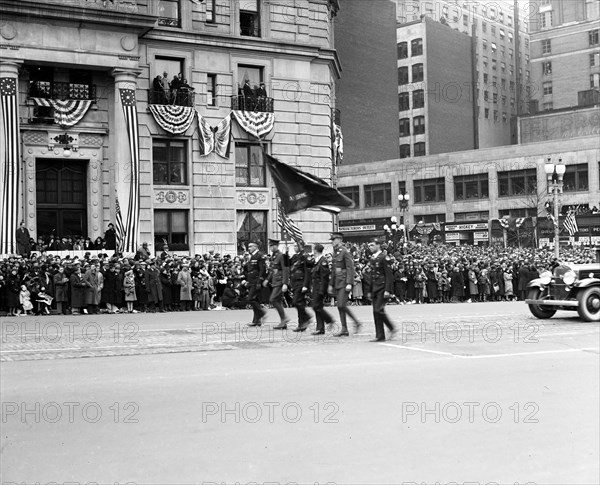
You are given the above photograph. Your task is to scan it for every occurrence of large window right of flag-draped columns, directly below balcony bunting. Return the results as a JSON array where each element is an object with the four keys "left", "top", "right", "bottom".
[{"left": 152, "top": 140, "right": 187, "bottom": 185}]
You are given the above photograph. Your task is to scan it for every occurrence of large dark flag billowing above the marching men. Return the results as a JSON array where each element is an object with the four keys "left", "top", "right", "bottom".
[{"left": 263, "top": 152, "right": 354, "bottom": 214}]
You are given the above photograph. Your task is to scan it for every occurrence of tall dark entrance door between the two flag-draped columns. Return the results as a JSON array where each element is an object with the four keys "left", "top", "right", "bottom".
[{"left": 35, "top": 159, "right": 88, "bottom": 238}]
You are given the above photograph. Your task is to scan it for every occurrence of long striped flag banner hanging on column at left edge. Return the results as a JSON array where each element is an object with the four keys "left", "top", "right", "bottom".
[{"left": 0, "top": 77, "right": 20, "bottom": 254}]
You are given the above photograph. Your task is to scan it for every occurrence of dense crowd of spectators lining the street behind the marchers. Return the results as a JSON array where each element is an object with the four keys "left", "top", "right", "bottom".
[{"left": 0, "top": 238, "right": 595, "bottom": 315}]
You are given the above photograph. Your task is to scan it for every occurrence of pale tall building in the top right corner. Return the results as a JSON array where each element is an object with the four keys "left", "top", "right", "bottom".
[{"left": 529, "top": 0, "right": 600, "bottom": 111}]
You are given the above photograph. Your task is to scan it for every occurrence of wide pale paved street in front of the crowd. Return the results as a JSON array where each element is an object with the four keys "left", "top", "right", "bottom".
[{"left": 0, "top": 302, "right": 600, "bottom": 484}]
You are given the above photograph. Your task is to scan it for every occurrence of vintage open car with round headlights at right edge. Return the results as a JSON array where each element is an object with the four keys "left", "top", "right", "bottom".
[{"left": 525, "top": 253, "right": 600, "bottom": 322}]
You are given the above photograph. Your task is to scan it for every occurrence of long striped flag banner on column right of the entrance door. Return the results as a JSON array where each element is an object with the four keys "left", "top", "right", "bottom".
[{"left": 119, "top": 89, "right": 140, "bottom": 252}]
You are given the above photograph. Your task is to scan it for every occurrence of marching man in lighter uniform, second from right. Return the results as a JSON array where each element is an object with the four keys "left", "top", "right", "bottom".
[{"left": 328, "top": 232, "right": 361, "bottom": 337}]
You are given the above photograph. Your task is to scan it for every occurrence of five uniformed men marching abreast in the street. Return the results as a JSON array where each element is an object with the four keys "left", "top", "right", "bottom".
[{"left": 246, "top": 232, "right": 396, "bottom": 342}]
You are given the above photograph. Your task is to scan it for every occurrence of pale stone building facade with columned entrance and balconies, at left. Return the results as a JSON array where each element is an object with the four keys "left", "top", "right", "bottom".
[{"left": 0, "top": 0, "right": 341, "bottom": 254}]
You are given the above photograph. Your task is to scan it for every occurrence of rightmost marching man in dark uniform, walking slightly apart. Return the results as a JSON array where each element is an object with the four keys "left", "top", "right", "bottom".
[{"left": 368, "top": 238, "right": 396, "bottom": 342}]
